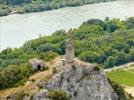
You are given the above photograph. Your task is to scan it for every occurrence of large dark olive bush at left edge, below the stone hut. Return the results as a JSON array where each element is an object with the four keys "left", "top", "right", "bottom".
[{"left": 0, "top": 65, "right": 32, "bottom": 89}]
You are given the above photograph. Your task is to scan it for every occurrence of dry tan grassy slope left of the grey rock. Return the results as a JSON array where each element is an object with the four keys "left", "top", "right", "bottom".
[{"left": 0, "top": 57, "right": 63, "bottom": 100}]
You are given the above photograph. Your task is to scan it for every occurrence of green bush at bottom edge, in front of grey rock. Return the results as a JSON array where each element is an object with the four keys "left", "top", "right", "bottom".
[{"left": 48, "top": 90, "right": 71, "bottom": 100}]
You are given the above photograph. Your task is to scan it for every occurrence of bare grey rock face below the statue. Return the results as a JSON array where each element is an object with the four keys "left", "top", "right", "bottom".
[{"left": 33, "top": 59, "right": 118, "bottom": 100}]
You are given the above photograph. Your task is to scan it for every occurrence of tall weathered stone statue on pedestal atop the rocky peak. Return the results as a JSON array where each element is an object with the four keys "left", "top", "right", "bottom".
[{"left": 65, "top": 29, "right": 75, "bottom": 64}]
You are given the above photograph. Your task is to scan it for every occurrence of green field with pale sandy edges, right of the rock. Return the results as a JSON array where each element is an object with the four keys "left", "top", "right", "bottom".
[{"left": 106, "top": 65, "right": 134, "bottom": 97}]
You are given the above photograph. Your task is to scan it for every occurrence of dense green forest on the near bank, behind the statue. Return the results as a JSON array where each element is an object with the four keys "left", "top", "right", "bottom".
[{"left": 0, "top": 17, "right": 134, "bottom": 88}]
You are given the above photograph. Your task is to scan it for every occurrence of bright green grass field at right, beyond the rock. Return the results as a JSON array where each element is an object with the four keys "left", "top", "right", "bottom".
[{"left": 106, "top": 70, "right": 134, "bottom": 86}]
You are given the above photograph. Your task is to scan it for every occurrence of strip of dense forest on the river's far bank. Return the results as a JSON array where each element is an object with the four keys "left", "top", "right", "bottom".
[{"left": 0, "top": 0, "right": 115, "bottom": 16}]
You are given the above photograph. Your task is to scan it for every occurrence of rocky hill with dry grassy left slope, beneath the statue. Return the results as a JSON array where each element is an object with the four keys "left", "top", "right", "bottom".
[{"left": 0, "top": 57, "right": 132, "bottom": 100}]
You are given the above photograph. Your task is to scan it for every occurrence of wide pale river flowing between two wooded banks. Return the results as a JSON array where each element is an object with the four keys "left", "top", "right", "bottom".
[{"left": 0, "top": 0, "right": 134, "bottom": 51}]
